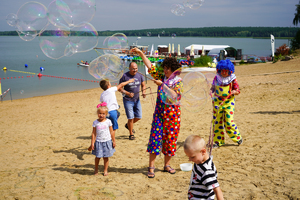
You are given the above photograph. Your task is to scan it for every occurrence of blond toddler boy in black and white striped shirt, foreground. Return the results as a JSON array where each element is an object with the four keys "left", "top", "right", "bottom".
[{"left": 184, "top": 135, "right": 223, "bottom": 200}]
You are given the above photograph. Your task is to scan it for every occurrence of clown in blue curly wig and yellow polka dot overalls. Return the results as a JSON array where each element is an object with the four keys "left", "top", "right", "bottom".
[{"left": 211, "top": 60, "right": 243, "bottom": 148}]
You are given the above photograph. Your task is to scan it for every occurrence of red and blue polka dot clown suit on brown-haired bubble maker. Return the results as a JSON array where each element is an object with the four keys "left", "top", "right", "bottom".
[{"left": 147, "top": 66, "right": 182, "bottom": 156}]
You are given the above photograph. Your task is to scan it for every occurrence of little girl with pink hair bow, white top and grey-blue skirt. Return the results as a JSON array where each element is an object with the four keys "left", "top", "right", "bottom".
[{"left": 91, "top": 102, "right": 116, "bottom": 176}]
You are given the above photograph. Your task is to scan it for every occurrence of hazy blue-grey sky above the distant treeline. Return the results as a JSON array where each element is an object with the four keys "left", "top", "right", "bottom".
[{"left": 0, "top": 0, "right": 300, "bottom": 31}]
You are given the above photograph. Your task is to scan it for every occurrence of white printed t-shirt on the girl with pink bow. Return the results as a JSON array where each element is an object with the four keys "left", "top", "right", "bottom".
[{"left": 93, "top": 119, "right": 112, "bottom": 142}]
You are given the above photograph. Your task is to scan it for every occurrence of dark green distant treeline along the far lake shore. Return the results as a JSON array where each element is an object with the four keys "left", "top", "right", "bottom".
[{"left": 0, "top": 27, "right": 299, "bottom": 38}]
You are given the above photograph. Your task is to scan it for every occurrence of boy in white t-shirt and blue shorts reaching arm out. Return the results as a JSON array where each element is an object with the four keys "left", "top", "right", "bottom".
[{"left": 88, "top": 78, "right": 134, "bottom": 151}]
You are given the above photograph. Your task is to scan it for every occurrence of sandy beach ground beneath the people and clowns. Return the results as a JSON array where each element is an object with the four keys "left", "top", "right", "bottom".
[{"left": 0, "top": 58, "right": 300, "bottom": 200}]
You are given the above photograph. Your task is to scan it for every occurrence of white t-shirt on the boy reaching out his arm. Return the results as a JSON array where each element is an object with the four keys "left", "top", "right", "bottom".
[{"left": 100, "top": 86, "right": 119, "bottom": 112}]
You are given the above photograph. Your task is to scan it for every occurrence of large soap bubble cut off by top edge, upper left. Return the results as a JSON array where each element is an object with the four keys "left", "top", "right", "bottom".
[{"left": 56, "top": 0, "right": 96, "bottom": 27}]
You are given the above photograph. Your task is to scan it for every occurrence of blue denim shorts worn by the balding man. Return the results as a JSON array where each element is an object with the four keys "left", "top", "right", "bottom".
[{"left": 123, "top": 99, "right": 142, "bottom": 119}]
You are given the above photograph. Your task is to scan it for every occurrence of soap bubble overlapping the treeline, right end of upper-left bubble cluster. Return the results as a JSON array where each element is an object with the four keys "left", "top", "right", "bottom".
[{"left": 70, "top": 23, "right": 98, "bottom": 53}]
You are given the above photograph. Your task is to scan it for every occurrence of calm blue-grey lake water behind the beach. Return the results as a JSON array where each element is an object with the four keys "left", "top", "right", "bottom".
[{"left": 0, "top": 36, "right": 288, "bottom": 100}]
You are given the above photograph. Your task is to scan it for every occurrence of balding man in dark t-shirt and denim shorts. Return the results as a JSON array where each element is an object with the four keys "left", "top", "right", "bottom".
[{"left": 119, "top": 62, "right": 146, "bottom": 140}]
